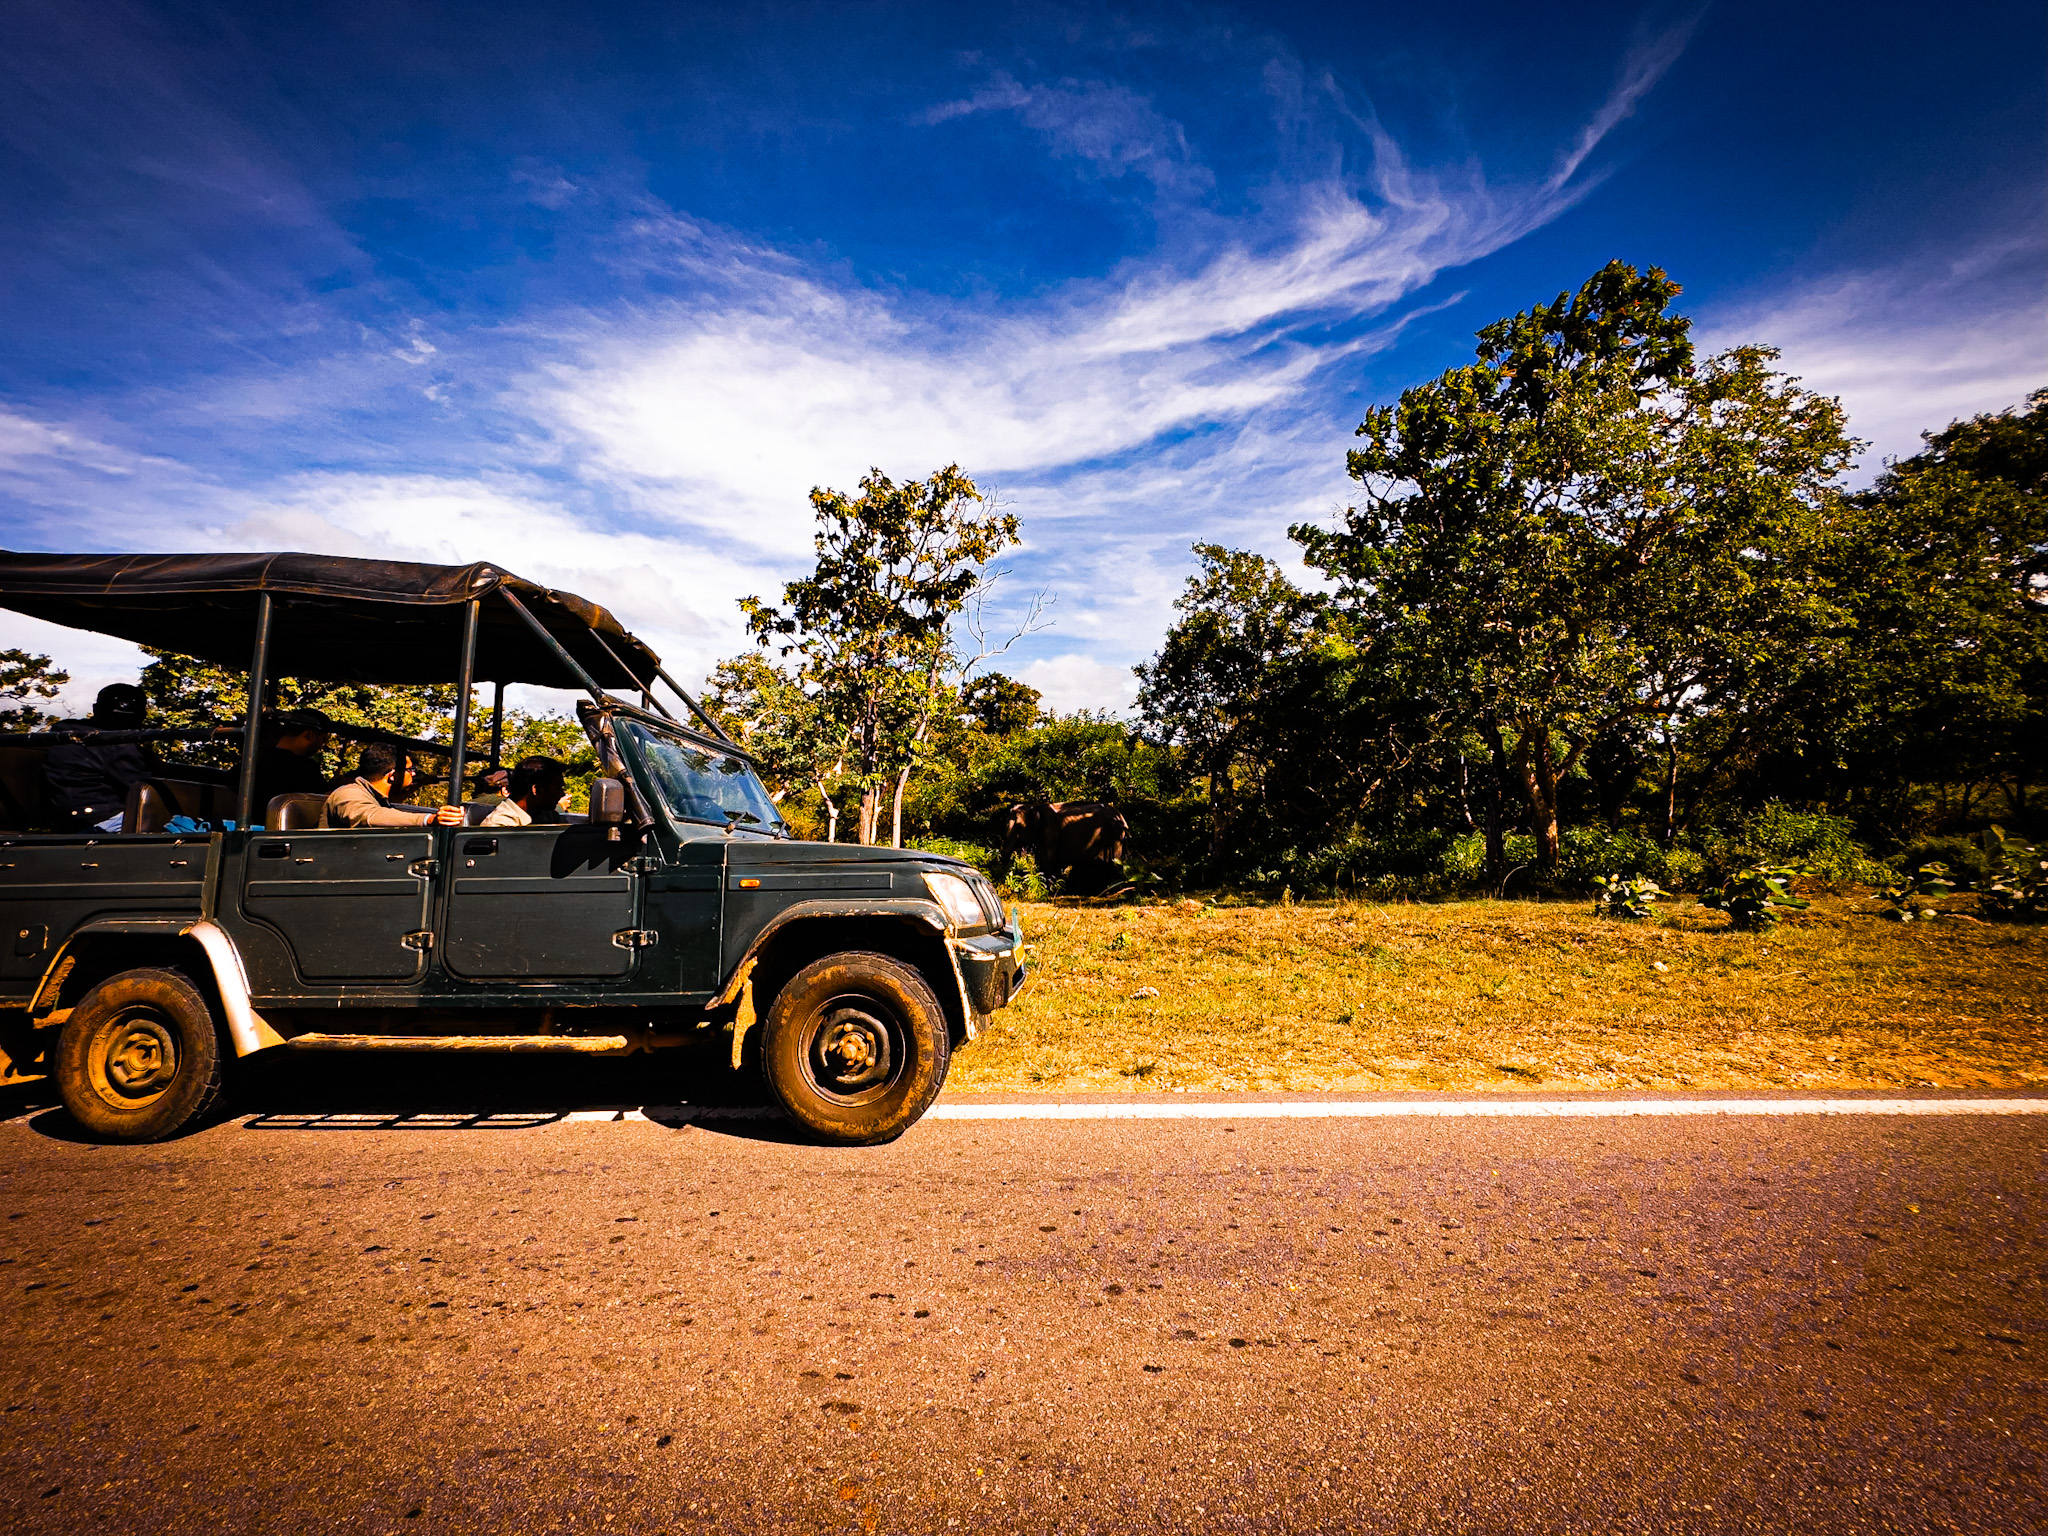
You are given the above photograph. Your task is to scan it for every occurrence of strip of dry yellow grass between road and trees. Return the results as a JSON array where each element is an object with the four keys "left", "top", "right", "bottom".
[{"left": 950, "top": 899, "right": 2048, "bottom": 1092}]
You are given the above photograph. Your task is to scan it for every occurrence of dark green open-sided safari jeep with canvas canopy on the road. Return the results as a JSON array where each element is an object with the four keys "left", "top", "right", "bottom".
[{"left": 0, "top": 553, "right": 1024, "bottom": 1145}]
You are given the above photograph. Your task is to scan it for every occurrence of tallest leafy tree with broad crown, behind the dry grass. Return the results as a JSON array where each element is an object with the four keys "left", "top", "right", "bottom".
[{"left": 1290, "top": 262, "right": 1853, "bottom": 872}]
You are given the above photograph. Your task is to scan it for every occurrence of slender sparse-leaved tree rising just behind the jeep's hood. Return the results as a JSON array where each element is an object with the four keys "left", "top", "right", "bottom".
[{"left": 739, "top": 465, "right": 1018, "bottom": 846}]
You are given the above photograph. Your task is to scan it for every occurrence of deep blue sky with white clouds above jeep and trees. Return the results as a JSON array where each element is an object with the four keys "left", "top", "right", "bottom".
[{"left": 0, "top": 0, "right": 2048, "bottom": 707}]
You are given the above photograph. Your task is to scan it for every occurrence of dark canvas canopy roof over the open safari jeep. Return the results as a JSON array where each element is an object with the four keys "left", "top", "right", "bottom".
[{"left": 0, "top": 551, "right": 662, "bottom": 690}]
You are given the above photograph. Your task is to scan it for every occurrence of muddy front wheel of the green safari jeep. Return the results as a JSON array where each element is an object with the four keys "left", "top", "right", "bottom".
[{"left": 762, "top": 950, "right": 952, "bottom": 1147}]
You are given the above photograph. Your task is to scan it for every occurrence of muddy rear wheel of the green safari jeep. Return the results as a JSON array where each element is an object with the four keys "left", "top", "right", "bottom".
[{"left": 53, "top": 969, "right": 221, "bottom": 1141}]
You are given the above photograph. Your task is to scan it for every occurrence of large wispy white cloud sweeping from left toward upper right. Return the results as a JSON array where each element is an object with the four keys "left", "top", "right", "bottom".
[{"left": 0, "top": 18, "right": 1675, "bottom": 707}]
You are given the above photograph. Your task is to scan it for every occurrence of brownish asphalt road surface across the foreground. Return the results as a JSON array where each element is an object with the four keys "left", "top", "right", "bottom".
[{"left": 0, "top": 1063, "right": 2048, "bottom": 1534}]
